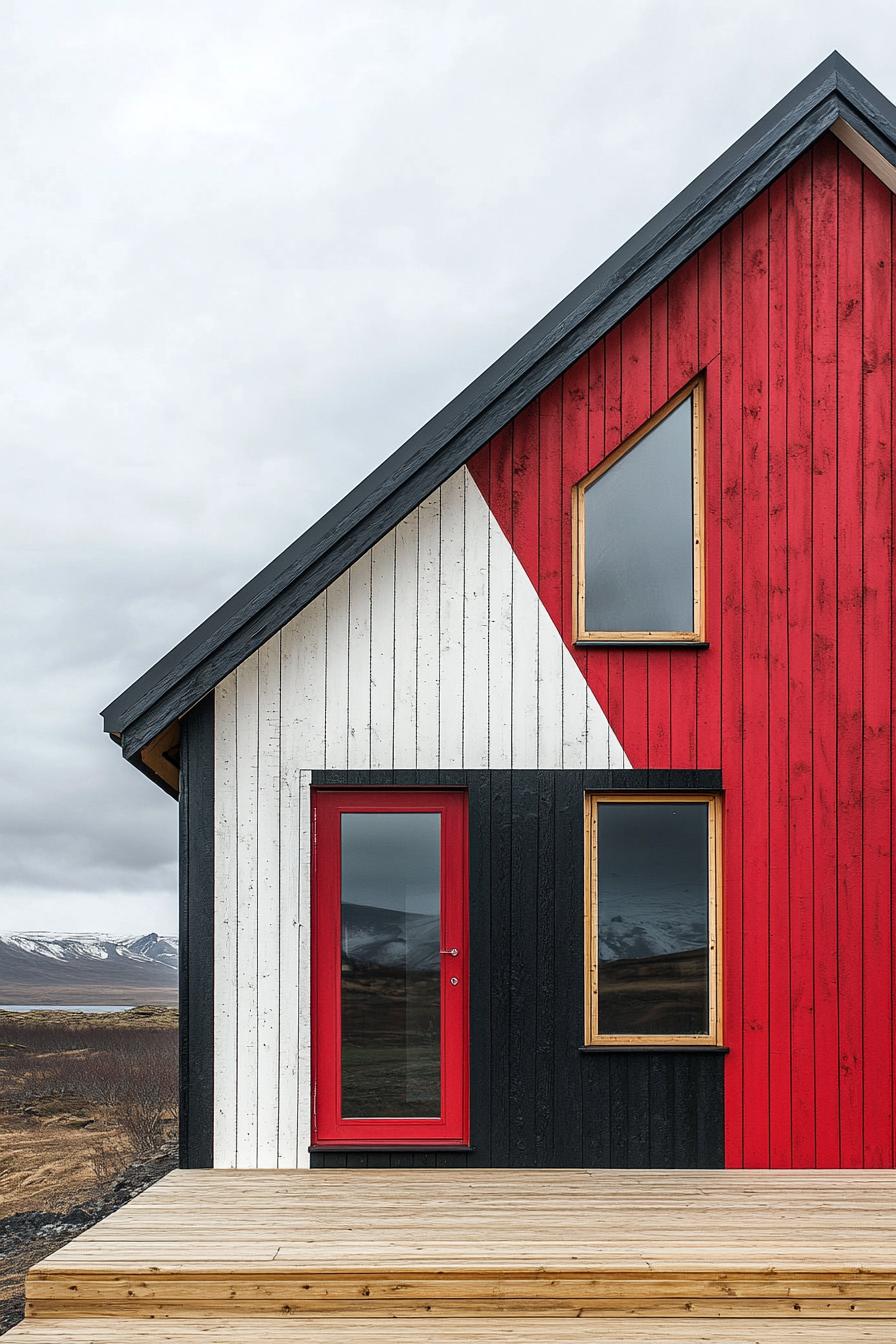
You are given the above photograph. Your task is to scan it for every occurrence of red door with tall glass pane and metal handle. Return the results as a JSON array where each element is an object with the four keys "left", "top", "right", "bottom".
[{"left": 312, "top": 789, "right": 469, "bottom": 1146}]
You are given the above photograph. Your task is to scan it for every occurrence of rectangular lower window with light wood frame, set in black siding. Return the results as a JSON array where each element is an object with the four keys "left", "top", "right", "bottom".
[{"left": 584, "top": 794, "right": 721, "bottom": 1046}]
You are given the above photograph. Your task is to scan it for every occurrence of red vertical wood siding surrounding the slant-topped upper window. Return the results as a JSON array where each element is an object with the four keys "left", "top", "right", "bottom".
[{"left": 470, "top": 137, "right": 895, "bottom": 1167}]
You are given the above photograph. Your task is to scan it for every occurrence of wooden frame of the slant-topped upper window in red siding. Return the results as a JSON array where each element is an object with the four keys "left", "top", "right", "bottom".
[{"left": 572, "top": 374, "right": 707, "bottom": 644}]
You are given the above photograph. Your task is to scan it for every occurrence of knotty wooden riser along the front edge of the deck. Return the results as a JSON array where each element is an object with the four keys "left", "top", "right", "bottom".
[{"left": 27, "top": 1263, "right": 896, "bottom": 1317}]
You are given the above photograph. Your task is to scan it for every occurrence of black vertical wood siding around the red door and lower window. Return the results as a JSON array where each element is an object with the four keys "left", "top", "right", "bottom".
[{"left": 312, "top": 770, "right": 724, "bottom": 1167}]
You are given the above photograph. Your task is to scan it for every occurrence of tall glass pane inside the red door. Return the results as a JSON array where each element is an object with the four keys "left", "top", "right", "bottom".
[{"left": 341, "top": 812, "right": 441, "bottom": 1120}]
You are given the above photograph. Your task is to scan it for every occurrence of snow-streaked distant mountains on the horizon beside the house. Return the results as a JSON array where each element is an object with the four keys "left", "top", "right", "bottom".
[{"left": 0, "top": 933, "right": 177, "bottom": 1005}]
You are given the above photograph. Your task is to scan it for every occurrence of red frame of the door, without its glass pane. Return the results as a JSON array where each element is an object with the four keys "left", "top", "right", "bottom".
[{"left": 312, "top": 789, "right": 470, "bottom": 1148}]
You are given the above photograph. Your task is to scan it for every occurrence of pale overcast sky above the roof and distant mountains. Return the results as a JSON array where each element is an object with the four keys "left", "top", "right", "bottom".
[{"left": 0, "top": 0, "right": 896, "bottom": 934}]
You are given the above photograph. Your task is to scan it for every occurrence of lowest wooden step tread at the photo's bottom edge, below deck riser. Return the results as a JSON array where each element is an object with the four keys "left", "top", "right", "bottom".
[{"left": 4, "top": 1316, "right": 893, "bottom": 1344}]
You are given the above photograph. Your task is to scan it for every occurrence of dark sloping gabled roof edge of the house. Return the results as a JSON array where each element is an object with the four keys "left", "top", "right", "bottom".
[{"left": 103, "top": 52, "right": 896, "bottom": 792}]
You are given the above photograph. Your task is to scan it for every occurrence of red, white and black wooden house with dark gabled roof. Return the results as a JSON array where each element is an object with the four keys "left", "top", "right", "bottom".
[{"left": 105, "top": 54, "right": 896, "bottom": 1168}]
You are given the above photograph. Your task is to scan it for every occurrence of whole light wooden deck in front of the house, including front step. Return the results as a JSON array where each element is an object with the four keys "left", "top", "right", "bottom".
[{"left": 13, "top": 1169, "right": 896, "bottom": 1344}]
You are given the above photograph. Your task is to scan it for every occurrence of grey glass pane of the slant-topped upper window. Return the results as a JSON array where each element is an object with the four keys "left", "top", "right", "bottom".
[{"left": 584, "top": 396, "right": 693, "bottom": 632}]
